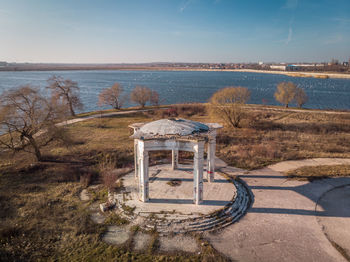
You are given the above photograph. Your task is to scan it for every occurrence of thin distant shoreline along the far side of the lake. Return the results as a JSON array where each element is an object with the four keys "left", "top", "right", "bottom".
[{"left": 0, "top": 66, "right": 350, "bottom": 79}]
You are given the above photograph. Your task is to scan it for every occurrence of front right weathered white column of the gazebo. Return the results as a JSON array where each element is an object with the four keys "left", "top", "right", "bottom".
[{"left": 193, "top": 141, "right": 204, "bottom": 205}]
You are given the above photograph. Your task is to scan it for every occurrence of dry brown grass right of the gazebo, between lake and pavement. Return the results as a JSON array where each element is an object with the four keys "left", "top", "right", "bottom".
[{"left": 213, "top": 109, "right": 350, "bottom": 169}]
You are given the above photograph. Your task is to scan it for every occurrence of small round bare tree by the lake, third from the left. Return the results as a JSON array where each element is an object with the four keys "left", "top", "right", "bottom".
[{"left": 98, "top": 83, "right": 126, "bottom": 109}]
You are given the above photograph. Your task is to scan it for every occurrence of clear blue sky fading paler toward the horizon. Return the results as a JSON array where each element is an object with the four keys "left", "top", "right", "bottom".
[{"left": 0, "top": 0, "right": 350, "bottom": 63}]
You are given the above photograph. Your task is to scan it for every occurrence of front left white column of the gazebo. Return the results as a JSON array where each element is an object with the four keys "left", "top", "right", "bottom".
[{"left": 137, "top": 140, "right": 149, "bottom": 202}]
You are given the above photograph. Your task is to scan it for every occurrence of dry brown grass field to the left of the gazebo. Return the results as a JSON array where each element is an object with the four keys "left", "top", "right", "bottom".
[{"left": 0, "top": 113, "right": 213, "bottom": 261}]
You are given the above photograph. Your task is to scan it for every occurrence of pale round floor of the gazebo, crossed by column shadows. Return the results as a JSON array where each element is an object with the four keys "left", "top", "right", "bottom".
[{"left": 118, "top": 164, "right": 236, "bottom": 215}]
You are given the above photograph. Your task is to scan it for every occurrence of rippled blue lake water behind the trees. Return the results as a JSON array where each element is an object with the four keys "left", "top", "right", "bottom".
[{"left": 0, "top": 70, "right": 350, "bottom": 111}]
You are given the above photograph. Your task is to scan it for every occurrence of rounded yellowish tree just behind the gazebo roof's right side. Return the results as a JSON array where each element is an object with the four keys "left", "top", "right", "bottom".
[{"left": 209, "top": 87, "right": 250, "bottom": 127}]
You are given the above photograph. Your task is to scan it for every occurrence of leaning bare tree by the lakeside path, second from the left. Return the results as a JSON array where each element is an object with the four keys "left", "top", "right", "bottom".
[{"left": 47, "top": 76, "right": 83, "bottom": 116}]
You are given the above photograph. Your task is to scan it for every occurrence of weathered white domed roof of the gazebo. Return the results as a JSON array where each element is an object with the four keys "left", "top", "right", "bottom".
[{"left": 130, "top": 118, "right": 218, "bottom": 139}]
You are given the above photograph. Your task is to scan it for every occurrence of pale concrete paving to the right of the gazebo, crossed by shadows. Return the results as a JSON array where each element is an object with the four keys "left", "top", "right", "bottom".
[{"left": 205, "top": 158, "right": 350, "bottom": 262}]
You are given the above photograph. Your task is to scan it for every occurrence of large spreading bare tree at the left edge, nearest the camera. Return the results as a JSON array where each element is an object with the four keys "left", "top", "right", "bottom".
[{"left": 0, "top": 85, "right": 68, "bottom": 161}]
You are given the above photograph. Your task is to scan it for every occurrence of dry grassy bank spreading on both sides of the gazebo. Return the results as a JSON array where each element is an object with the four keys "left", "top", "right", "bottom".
[{"left": 0, "top": 105, "right": 350, "bottom": 261}]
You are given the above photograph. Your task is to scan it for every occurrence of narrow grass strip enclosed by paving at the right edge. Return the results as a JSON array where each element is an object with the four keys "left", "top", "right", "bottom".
[{"left": 286, "top": 165, "right": 350, "bottom": 181}]
